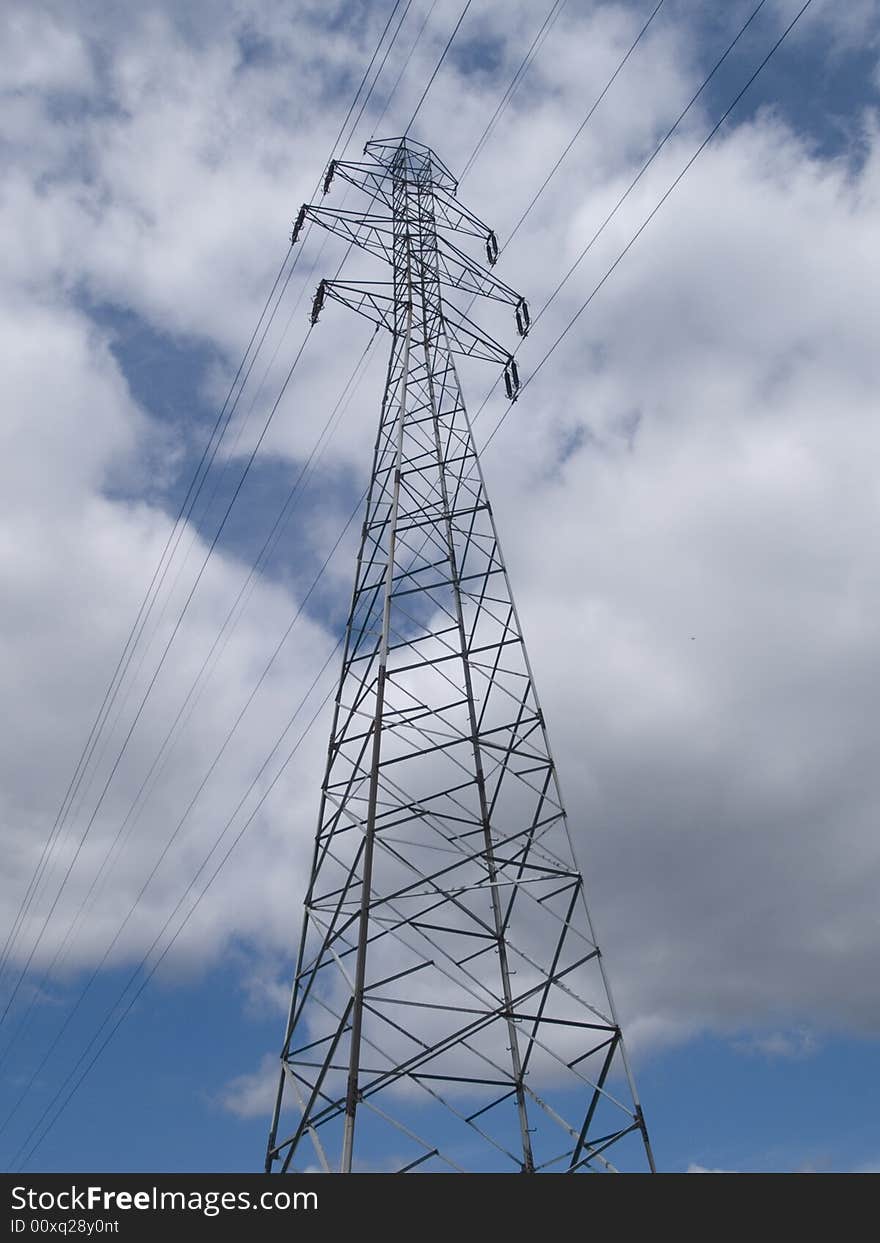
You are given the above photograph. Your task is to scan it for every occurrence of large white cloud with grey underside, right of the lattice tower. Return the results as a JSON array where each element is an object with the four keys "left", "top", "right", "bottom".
[{"left": 487, "top": 104, "right": 880, "bottom": 1049}]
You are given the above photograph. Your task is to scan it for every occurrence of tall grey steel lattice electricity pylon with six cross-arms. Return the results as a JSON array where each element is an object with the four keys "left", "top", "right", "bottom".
[{"left": 266, "top": 138, "right": 653, "bottom": 1172}]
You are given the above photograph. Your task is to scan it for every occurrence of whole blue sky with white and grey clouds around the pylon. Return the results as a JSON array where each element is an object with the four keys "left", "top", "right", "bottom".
[{"left": 0, "top": 0, "right": 880, "bottom": 1172}]
